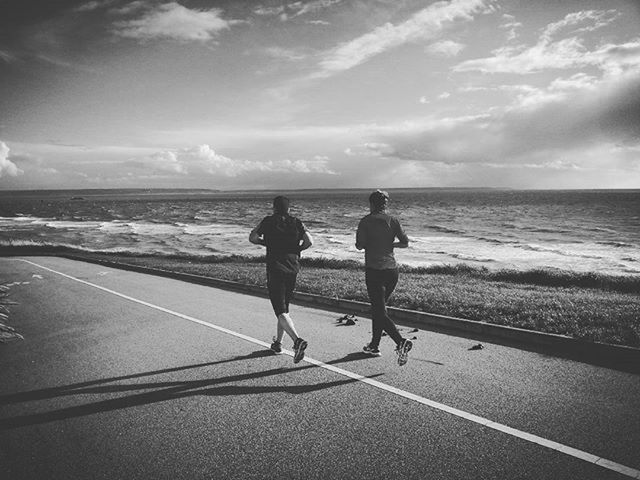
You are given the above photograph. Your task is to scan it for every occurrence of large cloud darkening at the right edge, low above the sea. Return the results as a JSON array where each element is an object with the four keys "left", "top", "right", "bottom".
[{"left": 372, "top": 74, "right": 640, "bottom": 169}]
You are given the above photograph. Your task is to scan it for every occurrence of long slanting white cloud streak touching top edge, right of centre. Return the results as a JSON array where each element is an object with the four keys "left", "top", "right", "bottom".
[{"left": 312, "top": 0, "right": 493, "bottom": 78}]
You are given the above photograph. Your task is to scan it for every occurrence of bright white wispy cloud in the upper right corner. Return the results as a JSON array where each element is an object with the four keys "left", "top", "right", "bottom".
[{"left": 453, "top": 11, "right": 640, "bottom": 75}]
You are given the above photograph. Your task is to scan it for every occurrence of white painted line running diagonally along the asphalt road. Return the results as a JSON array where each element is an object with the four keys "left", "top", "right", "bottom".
[{"left": 18, "top": 259, "right": 640, "bottom": 480}]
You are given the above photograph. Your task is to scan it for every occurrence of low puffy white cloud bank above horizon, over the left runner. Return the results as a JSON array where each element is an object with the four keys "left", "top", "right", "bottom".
[{"left": 129, "top": 144, "right": 335, "bottom": 178}]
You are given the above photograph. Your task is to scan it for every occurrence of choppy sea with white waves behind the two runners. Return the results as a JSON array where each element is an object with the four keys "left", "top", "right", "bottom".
[{"left": 0, "top": 189, "right": 640, "bottom": 276}]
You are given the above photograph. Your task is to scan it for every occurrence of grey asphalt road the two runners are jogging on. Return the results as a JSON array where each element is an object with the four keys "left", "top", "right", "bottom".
[{"left": 0, "top": 257, "right": 640, "bottom": 480}]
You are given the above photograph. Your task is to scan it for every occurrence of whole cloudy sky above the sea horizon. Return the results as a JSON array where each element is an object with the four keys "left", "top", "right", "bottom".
[{"left": 0, "top": 0, "right": 640, "bottom": 190}]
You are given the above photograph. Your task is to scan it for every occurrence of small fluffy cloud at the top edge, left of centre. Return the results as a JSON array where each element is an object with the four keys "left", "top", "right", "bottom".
[{"left": 114, "top": 2, "right": 239, "bottom": 42}]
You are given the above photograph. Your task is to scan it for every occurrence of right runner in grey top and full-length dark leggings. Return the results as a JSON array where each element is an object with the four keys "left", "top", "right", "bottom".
[{"left": 356, "top": 190, "right": 413, "bottom": 366}]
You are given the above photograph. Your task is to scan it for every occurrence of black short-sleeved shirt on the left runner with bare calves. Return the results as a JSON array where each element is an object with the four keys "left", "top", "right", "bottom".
[{"left": 256, "top": 214, "right": 307, "bottom": 273}]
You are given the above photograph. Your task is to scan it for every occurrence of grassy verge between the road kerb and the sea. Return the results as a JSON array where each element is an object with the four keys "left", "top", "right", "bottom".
[{"left": 51, "top": 253, "right": 640, "bottom": 347}]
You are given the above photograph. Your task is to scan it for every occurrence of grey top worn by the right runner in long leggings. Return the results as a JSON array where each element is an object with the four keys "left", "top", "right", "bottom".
[{"left": 356, "top": 213, "right": 409, "bottom": 270}]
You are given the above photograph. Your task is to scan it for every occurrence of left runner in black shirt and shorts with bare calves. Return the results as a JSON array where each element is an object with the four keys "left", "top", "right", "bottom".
[{"left": 249, "top": 196, "right": 313, "bottom": 363}]
